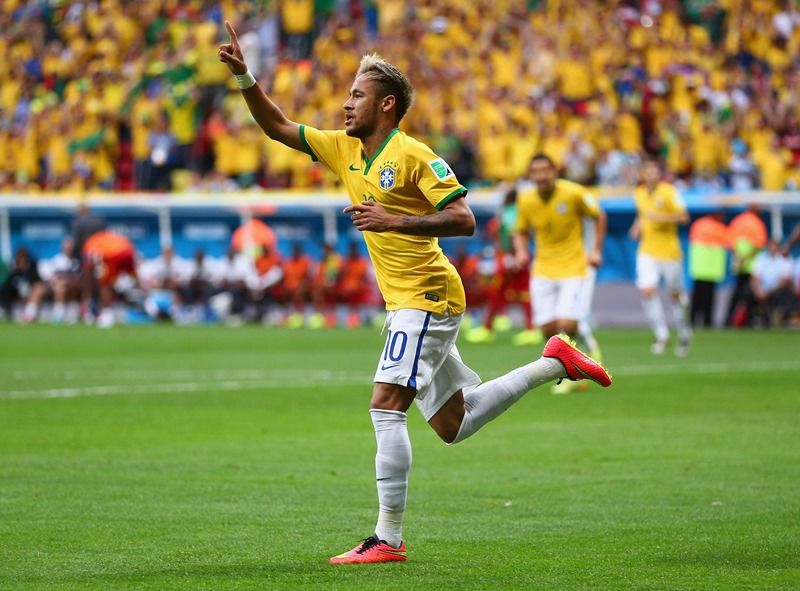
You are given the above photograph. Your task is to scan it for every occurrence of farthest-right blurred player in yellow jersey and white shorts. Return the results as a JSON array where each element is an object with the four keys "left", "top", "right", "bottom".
[{"left": 630, "top": 158, "right": 692, "bottom": 357}]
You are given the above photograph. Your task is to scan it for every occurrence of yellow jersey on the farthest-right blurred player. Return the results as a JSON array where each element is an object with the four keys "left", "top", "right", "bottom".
[{"left": 633, "top": 182, "right": 686, "bottom": 261}]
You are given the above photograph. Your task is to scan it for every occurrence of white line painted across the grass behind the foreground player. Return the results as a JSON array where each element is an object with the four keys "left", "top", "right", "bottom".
[{"left": 0, "top": 360, "right": 800, "bottom": 400}]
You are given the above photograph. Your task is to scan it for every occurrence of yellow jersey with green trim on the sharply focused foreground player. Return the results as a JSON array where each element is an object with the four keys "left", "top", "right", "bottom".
[{"left": 300, "top": 125, "right": 467, "bottom": 314}]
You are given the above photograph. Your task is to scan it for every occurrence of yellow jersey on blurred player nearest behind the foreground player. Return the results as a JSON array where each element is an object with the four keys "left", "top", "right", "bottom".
[{"left": 517, "top": 179, "right": 600, "bottom": 279}]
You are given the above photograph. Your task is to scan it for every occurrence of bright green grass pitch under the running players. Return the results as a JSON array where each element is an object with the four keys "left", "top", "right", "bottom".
[{"left": 0, "top": 325, "right": 800, "bottom": 591}]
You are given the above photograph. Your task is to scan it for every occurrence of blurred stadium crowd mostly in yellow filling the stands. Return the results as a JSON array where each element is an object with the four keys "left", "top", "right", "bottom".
[{"left": 0, "top": 0, "right": 800, "bottom": 192}]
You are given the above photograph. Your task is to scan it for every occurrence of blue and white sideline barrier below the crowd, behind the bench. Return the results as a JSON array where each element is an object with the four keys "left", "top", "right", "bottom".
[{"left": 0, "top": 188, "right": 800, "bottom": 281}]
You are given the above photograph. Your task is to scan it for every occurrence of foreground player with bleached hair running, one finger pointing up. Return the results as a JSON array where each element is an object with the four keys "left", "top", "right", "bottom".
[{"left": 219, "top": 22, "right": 611, "bottom": 564}]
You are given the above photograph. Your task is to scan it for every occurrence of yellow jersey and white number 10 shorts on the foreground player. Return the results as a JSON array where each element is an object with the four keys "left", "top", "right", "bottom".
[{"left": 300, "top": 125, "right": 481, "bottom": 420}]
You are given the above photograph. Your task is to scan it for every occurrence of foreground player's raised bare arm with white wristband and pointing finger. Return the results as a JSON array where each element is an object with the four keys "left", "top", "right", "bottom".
[{"left": 219, "top": 21, "right": 305, "bottom": 152}]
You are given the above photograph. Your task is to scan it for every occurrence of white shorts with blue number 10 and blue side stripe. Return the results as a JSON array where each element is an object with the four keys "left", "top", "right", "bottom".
[{"left": 374, "top": 309, "right": 481, "bottom": 421}]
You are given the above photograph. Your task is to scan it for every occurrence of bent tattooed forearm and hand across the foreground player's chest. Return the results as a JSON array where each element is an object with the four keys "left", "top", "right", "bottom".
[{"left": 344, "top": 199, "right": 475, "bottom": 236}]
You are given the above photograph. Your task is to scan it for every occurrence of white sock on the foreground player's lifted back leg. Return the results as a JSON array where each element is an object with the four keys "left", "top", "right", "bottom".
[{"left": 451, "top": 357, "right": 567, "bottom": 445}]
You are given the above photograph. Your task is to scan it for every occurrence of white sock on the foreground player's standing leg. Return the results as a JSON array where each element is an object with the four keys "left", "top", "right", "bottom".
[{"left": 369, "top": 409, "right": 411, "bottom": 548}]
